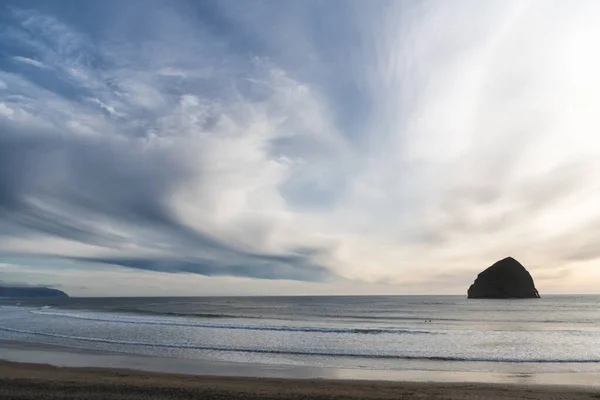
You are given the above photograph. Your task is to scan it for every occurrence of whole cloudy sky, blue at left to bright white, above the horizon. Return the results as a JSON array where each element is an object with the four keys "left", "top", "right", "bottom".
[{"left": 0, "top": 0, "right": 600, "bottom": 296}]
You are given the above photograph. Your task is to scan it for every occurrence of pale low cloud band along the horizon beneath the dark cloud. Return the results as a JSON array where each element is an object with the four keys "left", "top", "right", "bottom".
[{"left": 0, "top": 259, "right": 432, "bottom": 296}]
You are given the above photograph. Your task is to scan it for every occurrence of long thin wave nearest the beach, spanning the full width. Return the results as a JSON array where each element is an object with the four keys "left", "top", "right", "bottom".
[{"left": 0, "top": 326, "right": 600, "bottom": 364}]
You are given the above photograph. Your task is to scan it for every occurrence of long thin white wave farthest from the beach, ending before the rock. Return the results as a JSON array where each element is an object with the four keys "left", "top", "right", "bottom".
[{"left": 30, "top": 310, "right": 441, "bottom": 335}]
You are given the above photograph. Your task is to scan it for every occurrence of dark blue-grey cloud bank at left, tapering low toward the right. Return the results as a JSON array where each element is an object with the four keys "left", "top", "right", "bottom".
[{"left": 0, "top": 118, "right": 326, "bottom": 280}]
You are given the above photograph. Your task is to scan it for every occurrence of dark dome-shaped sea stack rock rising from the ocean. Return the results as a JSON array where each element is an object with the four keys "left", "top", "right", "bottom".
[{"left": 468, "top": 257, "right": 540, "bottom": 299}]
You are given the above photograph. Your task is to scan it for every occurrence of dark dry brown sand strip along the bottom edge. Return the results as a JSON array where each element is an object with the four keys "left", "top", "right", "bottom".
[{"left": 0, "top": 361, "right": 600, "bottom": 400}]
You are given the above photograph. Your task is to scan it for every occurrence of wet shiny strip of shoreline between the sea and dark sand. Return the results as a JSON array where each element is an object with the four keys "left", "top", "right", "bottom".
[{"left": 0, "top": 340, "right": 600, "bottom": 390}]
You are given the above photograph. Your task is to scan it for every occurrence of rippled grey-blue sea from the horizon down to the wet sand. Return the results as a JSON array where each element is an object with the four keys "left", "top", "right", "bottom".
[{"left": 0, "top": 296, "right": 600, "bottom": 373}]
